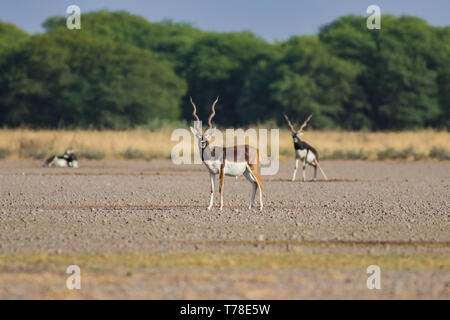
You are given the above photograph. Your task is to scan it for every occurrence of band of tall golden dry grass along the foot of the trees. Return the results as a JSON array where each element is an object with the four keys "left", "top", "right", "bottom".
[{"left": 0, "top": 128, "right": 450, "bottom": 160}]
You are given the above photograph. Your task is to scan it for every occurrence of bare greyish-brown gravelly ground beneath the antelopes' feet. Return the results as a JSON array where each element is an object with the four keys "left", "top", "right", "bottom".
[{"left": 0, "top": 160, "right": 450, "bottom": 299}]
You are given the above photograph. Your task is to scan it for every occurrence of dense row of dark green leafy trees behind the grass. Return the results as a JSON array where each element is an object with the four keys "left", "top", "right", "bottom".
[{"left": 0, "top": 11, "right": 450, "bottom": 130}]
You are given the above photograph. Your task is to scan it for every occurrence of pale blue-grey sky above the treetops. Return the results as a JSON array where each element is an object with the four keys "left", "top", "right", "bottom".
[{"left": 0, "top": 0, "right": 450, "bottom": 40}]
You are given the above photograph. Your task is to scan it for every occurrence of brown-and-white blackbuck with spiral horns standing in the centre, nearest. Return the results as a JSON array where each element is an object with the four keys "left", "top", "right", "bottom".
[{"left": 191, "top": 98, "right": 263, "bottom": 210}]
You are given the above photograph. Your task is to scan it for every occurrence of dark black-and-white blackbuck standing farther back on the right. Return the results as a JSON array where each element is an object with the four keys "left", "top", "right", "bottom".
[{"left": 284, "top": 114, "right": 328, "bottom": 181}]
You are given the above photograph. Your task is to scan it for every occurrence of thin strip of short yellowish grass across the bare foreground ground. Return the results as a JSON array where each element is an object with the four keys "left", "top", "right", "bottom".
[{"left": 0, "top": 251, "right": 450, "bottom": 270}]
